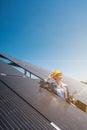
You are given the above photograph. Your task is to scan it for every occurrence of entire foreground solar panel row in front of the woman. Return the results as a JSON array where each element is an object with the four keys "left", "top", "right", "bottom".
[{"left": 0, "top": 53, "right": 87, "bottom": 130}]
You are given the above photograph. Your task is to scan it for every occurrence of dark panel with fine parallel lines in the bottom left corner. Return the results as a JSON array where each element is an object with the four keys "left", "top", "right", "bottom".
[{"left": 0, "top": 82, "right": 56, "bottom": 130}]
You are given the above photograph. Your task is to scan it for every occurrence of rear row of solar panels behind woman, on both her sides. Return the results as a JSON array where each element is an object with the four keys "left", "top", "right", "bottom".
[{"left": 0, "top": 54, "right": 87, "bottom": 105}]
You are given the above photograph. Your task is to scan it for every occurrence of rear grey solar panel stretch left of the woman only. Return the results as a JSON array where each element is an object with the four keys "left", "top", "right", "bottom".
[{"left": 0, "top": 54, "right": 51, "bottom": 79}]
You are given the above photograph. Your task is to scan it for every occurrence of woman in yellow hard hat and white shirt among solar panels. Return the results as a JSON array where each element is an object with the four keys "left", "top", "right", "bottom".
[{"left": 45, "top": 70, "right": 73, "bottom": 100}]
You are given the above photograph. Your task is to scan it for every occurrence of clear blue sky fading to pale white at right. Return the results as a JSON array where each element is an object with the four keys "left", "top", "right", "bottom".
[{"left": 0, "top": 0, "right": 87, "bottom": 81}]
